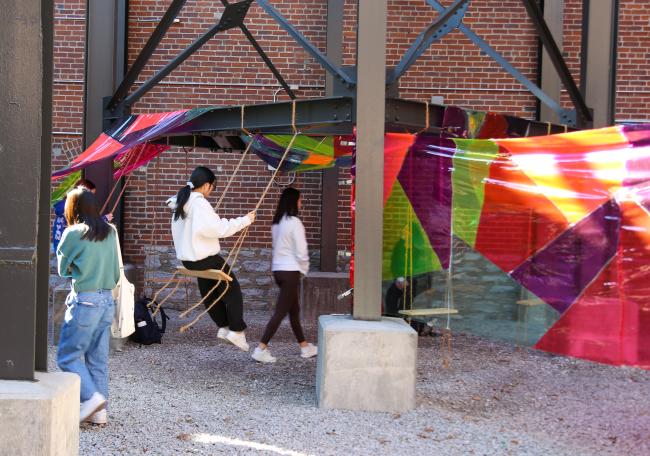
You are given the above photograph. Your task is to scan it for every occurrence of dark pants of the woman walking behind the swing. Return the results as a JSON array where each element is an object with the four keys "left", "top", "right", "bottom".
[{"left": 262, "top": 271, "right": 305, "bottom": 344}]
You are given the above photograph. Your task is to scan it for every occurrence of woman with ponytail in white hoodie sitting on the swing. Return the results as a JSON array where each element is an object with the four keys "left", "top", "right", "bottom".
[{"left": 168, "top": 166, "right": 255, "bottom": 351}]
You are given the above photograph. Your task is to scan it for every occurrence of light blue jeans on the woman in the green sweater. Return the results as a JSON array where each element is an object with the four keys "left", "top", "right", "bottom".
[{"left": 57, "top": 290, "right": 115, "bottom": 402}]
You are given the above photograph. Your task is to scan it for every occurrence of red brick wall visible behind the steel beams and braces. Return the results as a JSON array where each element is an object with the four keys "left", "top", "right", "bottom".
[{"left": 53, "top": 0, "right": 650, "bottom": 290}]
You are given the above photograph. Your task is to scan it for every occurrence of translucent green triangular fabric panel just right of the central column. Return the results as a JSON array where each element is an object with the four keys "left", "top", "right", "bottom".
[{"left": 382, "top": 181, "right": 442, "bottom": 280}]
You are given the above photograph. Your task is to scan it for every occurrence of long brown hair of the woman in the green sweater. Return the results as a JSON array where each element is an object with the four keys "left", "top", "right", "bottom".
[{"left": 65, "top": 187, "right": 111, "bottom": 242}]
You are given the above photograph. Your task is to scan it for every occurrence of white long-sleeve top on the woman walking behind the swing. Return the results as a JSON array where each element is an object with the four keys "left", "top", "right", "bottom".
[{"left": 271, "top": 215, "right": 309, "bottom": 275}]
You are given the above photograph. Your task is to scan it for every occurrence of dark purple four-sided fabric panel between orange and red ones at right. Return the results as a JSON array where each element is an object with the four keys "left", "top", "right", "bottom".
[{"left": 511, "top": 201, "right": 621, "bottom": 313}]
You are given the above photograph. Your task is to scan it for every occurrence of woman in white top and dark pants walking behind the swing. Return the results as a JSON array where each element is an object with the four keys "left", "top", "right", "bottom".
[{"left": 252, "top": 188, "right": 318, "bottom": 363}]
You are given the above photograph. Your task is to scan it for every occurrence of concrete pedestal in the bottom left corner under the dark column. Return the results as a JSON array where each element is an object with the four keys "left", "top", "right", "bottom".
[{"left": 0, "top": 372, "right": 79, "bottom": 456}]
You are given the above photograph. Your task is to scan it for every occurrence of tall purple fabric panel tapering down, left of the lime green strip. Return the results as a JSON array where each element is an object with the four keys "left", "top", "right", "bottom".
[{"left": 397, "top": 135, "right": 456, "bottom": 269}]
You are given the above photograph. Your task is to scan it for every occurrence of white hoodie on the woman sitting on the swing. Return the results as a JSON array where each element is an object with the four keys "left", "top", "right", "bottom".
[{"left": 167, "top": 192, "right": 251, "bottom": 261}]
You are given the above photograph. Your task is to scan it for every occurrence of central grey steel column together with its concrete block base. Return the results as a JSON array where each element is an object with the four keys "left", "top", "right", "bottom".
[{"left": 316, "top": 0, "right": 417, "bottom": 412}]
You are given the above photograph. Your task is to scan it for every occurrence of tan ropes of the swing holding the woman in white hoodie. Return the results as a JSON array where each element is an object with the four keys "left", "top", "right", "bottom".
[{"left": 153, "top": 100, "right": 300, "bottom": 332}]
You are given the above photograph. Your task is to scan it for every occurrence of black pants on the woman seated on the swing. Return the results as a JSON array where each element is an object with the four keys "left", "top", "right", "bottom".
[{"left": 183, "top": 255, "right": 246, "bottom": 331}]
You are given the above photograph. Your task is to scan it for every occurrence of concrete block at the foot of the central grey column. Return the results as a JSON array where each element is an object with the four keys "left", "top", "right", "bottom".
[{"left": 316, "top": 315, "right": 418, "bottom": 412}]
